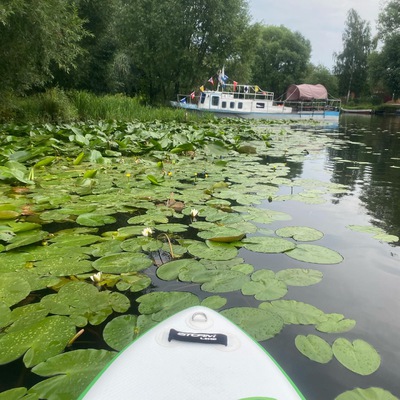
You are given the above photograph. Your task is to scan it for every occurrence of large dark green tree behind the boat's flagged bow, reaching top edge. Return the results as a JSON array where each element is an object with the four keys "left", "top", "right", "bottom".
[{"left": 110, "top": 0, "right": 249, "bottom": 102}]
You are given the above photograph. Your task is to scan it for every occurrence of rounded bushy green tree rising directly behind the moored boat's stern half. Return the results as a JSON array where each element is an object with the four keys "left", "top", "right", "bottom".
[{"left": 252, "top": 25, "right": 311, "bottom": 94}]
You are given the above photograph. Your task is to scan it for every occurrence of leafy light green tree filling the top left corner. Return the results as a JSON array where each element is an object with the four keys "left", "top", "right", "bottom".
[{"left": 0, "top": 0, "right": 86, "bottom": 92}]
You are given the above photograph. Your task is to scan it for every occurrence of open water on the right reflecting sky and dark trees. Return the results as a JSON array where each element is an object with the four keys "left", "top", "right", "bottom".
[{"left": 250, "top": 116, "right": 400, "bottom": 400}]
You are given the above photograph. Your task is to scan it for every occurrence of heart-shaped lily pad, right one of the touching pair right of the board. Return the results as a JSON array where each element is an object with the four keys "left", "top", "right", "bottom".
[{"left": 332, "top": 338, "right": 381, "bottom": 375}]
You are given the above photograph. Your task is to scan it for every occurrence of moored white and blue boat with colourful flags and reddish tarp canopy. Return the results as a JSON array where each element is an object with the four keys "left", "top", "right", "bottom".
[{"left": 171, "top": 77, "right": 340, "bottom": 122}]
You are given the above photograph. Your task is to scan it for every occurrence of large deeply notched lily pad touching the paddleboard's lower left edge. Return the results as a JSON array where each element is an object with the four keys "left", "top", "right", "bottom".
[{"left": 29, "top": 349, "right": 116, "bottom": 399}]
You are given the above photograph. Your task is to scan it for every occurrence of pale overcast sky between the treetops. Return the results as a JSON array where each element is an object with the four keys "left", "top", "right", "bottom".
[{"left": 248, "top": 0, "right": 381, "bottom": 68}]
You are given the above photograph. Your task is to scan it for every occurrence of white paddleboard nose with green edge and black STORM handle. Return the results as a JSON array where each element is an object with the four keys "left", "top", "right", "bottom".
[{"left": 79, "top": 306, "right": 305, "bottom": 400}]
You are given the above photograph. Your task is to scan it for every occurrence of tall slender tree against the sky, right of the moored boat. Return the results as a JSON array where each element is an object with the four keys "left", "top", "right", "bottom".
[{"left": 334, "top": 9, "right": 373, "bottom": 100}]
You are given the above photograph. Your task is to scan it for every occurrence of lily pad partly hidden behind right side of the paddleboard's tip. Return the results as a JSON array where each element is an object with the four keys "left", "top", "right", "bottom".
[{"left": 221, "top": 307, "right": 283, "bottom": 341}]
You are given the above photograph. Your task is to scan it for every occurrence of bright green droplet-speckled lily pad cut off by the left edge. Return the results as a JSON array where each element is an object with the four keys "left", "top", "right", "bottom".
[{"left": 0, "top": 315, "right": 75, "bottom": 368}]
